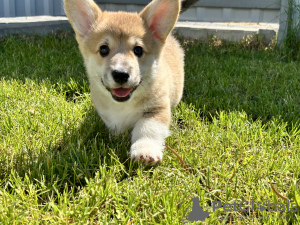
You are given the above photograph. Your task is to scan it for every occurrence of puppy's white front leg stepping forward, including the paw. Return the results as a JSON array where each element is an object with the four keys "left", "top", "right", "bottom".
[{"left": 130, "top": 113, "right": 170, "bottom": 164}]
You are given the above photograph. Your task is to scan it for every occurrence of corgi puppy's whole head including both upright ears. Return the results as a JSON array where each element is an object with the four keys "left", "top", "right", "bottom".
[{"left": 64, "top": 0, "right": 180, "bottom": 102}]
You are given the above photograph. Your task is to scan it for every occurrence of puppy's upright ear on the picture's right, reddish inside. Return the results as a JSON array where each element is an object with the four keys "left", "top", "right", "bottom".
[{"left": 140, "top": 0, "right": 180, "bottom": 42}]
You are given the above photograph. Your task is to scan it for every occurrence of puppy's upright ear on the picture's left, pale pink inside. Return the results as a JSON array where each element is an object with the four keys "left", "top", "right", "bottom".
[{"left": 64, "top": 0, "right": 102, "bottom": 38}]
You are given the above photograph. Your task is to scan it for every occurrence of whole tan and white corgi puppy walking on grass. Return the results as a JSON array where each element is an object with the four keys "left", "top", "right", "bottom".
[{"left": 64, "top": 0, "right": 188, "bottom": 165}]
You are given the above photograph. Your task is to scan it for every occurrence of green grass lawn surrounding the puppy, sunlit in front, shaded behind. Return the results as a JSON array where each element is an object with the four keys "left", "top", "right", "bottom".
[{"left": 0, "top": 32, "right": 300, "bottom": 225}]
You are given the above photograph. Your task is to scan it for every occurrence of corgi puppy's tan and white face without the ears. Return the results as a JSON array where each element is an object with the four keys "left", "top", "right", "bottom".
[{"left": 80, "top": 12, "right": 161, "bottom": 102}]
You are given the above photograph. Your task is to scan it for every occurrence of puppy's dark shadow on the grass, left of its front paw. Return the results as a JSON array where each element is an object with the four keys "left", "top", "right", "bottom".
[{"left": 0, "top": 106, "right": 143, "bottom": 195}]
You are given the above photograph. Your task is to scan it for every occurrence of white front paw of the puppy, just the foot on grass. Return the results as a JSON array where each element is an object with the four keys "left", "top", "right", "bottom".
[{"left": 129, "top": 140, "right": 164, "bottom": 165}]
